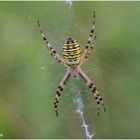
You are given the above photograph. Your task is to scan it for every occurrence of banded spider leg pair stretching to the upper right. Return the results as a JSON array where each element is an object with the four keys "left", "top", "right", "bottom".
[{"left": 80, "top": 11, "right": 96, "bottom": 65}]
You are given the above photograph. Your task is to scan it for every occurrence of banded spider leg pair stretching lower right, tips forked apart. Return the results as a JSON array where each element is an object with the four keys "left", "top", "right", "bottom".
[{"left": 79, "top": 69, "right": 106, "bottom": 115}]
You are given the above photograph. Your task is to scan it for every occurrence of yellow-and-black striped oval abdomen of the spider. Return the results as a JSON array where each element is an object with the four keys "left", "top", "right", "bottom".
[{"left": 63, "top": 37, "right": 81, "bottom": 66}]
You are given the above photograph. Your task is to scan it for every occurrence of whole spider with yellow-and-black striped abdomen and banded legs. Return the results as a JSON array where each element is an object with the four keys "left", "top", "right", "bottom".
[{"left": 37, "top": 11, "right": 105, "bottom": 116}]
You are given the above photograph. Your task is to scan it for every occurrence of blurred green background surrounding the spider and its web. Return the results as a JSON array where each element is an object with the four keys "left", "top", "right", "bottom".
[{"left": 0, "top": 1, "right": 140, "bottom": 138}]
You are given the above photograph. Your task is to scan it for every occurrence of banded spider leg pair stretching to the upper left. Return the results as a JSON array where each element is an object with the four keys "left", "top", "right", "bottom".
[{"left": 37, "top": 20, "right": 67, "bottom": 67}]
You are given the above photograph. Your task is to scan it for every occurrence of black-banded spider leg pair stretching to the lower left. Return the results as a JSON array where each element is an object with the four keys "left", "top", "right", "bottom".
[{"left": 54, "top": 72, "right": 71, "bottom": 116}]
